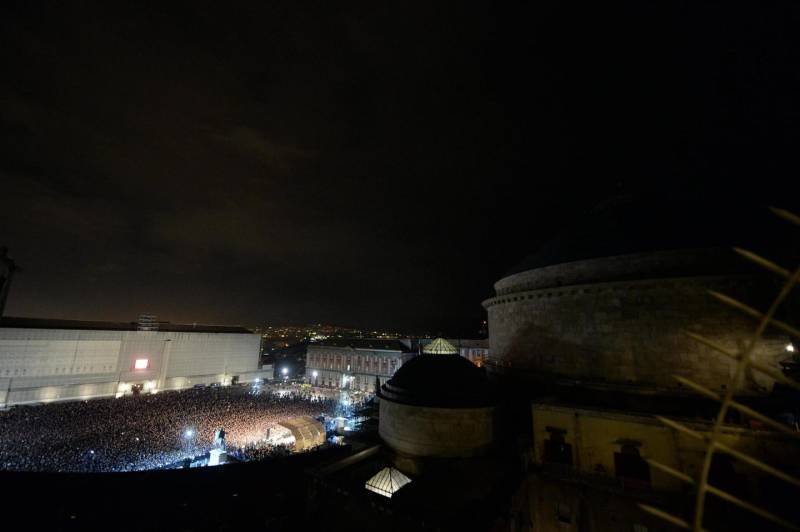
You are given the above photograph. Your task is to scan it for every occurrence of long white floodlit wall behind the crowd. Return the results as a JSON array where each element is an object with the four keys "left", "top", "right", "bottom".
[{"left": 0, "top": 328, "right": 260, "bottom": 406}]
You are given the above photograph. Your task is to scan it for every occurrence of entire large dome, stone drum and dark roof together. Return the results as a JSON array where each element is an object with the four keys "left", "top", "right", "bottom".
[{"left": 483, "top": 203, "right": 796, "bottom": 393}]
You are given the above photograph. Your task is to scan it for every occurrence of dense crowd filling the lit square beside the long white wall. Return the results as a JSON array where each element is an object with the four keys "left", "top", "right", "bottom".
[{"left": 0, "top": 386, "right": 334, "bottom": 471}]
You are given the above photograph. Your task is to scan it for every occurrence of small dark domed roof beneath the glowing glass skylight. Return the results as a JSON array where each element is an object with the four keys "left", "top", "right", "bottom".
[{"left": 378, "top": 353, "right": 492, "bottom": 408}]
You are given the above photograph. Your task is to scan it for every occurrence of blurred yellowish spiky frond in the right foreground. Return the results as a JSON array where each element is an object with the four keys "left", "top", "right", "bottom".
[{"left": 640, "top": 208, "right": 800, "bottom": 531}]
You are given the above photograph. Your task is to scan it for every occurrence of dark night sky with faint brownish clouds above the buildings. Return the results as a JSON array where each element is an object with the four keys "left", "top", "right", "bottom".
[{"left": 0, "top": 1, "right": 800, "bottom": 334}]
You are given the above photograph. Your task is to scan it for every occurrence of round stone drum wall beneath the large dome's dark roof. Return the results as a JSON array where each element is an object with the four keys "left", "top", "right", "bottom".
[{"left": 484, "top": 251, "right": 786, "bottom": 392}]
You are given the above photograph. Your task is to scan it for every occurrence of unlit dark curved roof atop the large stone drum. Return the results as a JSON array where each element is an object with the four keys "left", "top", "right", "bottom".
[{"left": 506, "top": 198, "right": 792, "bottom": 276}]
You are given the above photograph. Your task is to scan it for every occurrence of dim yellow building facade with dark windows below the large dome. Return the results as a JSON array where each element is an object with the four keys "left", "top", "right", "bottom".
[{"left": 526, "top": 402, "right": 800, "bottom": 532}]
